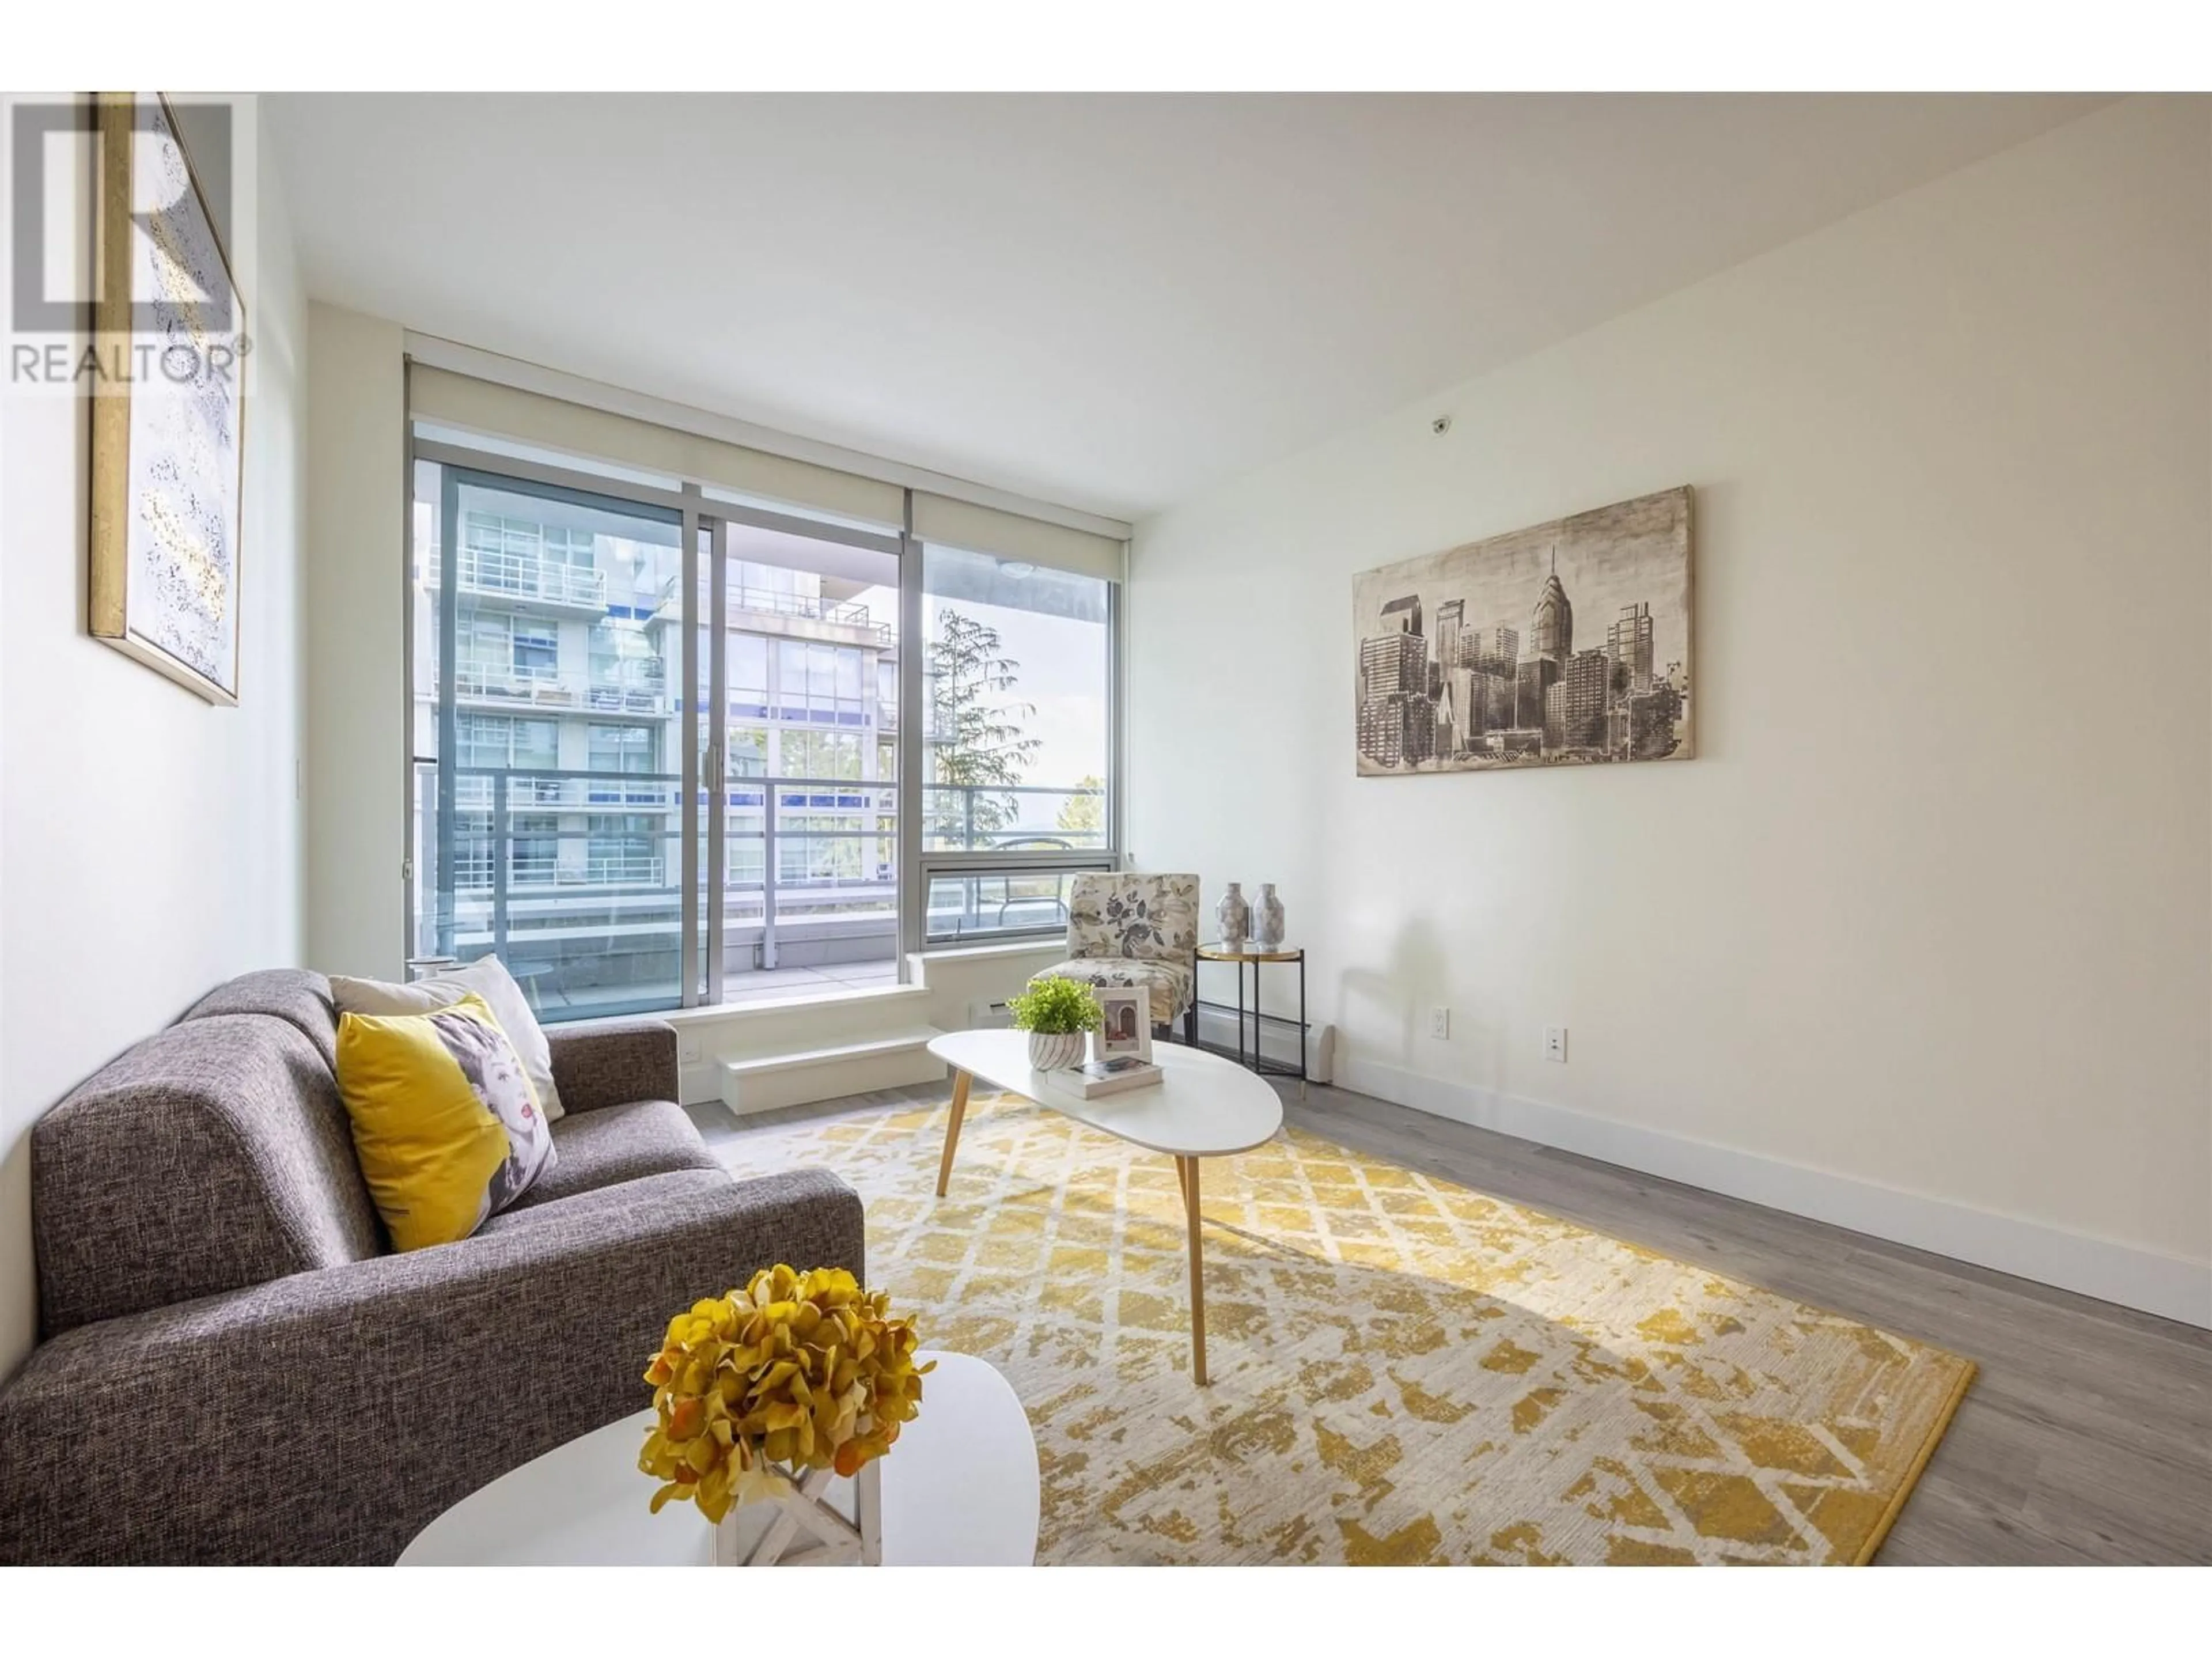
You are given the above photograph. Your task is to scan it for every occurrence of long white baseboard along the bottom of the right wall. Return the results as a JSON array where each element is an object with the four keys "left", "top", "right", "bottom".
[{"left": 1336, "top": 1055, "right": 2212, "bottom": 1327}]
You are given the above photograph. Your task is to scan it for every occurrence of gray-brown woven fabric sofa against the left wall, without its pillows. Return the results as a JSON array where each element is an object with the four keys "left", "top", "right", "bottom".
[{"left": 0, "top": 971, "right": 865, "bottom": 1562}]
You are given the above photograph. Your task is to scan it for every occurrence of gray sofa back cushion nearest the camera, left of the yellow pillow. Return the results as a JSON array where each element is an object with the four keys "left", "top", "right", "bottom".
[{"left": 31, "top": 1013, "right": 382, "bottom": 1336}]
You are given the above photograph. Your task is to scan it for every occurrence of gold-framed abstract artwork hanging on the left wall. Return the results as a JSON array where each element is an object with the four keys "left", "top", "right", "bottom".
[{"left": 86, "top": 93, "right": 245, "bottom": 706}]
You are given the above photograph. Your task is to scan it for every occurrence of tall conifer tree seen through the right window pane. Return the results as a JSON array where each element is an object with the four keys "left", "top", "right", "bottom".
[{"left": 929, "top": 611, "right": 1042, "bottom": 847}]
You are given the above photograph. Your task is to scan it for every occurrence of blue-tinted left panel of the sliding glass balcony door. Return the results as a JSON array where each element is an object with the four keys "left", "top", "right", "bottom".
[{"left": 411, "top": 463, "right": 690, "bottom": 1017}]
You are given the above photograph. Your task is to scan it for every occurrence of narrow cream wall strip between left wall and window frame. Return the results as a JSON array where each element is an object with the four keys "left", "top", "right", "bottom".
[{"left": 305, "top": 303, "right": 407, "bottom": 980}]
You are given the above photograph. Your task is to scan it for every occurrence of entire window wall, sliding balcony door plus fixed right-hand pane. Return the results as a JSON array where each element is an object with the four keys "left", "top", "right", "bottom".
[{"left": 411, "top": 429, "right": 1117, "bottom": 1020}]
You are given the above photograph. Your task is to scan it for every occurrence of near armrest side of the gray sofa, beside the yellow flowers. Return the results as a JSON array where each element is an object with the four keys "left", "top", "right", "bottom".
[{"left": 0, "top": 1170, "right": 865, "bottom": 1564}]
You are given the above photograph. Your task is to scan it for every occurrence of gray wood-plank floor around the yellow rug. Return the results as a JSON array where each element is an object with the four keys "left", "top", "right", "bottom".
[{"left": 690, "top": 1084, "right": 2212, "bottom": 1566}]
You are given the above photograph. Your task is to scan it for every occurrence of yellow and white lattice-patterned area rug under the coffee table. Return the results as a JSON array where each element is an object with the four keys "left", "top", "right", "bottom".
[{"left": 724, "top": 1095, "right": 1973, "bottom": 1564}]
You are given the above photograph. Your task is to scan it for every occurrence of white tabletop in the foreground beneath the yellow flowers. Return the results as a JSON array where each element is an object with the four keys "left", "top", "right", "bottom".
[{"left": 400, "top": 1354, "right": 1037, "bottom": 1566}]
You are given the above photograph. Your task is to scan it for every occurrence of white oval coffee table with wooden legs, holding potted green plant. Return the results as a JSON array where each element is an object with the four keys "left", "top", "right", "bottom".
[{"left": 929, "top": 1031, "right": 1283, "bottom": 1387}]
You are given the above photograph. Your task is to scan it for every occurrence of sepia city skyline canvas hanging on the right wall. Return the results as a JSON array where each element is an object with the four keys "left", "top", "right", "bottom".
[{"left": 1351, "top": 484, "right": 1692, "bottom": 777}]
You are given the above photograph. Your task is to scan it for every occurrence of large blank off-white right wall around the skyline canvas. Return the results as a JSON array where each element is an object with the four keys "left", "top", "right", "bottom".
[{"left": 1128, "top": 100, "right": 2212, "bottom": 1320}]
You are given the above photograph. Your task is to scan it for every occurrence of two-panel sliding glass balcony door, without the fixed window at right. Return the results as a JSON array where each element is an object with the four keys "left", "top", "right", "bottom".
[{"left": 409, "top": 435, "right": 907, "bottom": 1020}]
